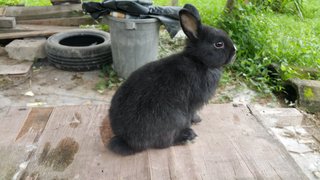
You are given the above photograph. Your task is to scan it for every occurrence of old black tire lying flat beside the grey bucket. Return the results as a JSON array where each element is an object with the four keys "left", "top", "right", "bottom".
[{"left": 46, "top": 29, "right": 112, "bottom": 71}]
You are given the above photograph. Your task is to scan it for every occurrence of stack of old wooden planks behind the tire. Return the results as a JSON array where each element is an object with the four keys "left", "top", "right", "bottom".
[{"left": 0, "top": 0, "right": 94, "bottom": 40}]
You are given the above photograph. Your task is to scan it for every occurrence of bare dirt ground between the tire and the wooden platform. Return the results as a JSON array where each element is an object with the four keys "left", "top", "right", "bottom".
[{"left": 0, "top": 61, "right": 114, "bottom": 108}]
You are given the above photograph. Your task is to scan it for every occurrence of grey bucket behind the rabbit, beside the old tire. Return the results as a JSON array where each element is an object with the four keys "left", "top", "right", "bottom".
[{"left": 104, "top": 16, "right": 160, "bottom": 78}]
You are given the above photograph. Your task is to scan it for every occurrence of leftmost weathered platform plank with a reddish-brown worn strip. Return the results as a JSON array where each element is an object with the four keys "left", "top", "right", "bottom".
[{"left": 0, "top": 107, "right": 52, "bottom": 179}]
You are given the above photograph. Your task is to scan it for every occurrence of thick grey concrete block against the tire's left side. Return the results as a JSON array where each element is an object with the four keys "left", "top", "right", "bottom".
[{"left": 5, "top": 38, "right": 46, "bottom": 61}]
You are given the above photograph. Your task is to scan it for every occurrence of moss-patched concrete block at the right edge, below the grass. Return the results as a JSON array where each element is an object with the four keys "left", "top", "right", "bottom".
[{"left": 286, "top": 78, "right": 320, "bottom": 113}]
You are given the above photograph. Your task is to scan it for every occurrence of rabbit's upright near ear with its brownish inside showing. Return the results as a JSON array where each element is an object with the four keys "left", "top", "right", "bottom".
[{"left": 179, "top": 4, "right": 202, "bottom": 41}]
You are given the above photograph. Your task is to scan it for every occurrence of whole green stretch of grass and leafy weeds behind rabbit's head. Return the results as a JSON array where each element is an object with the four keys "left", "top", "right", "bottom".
[{"left": 154, "top": 0, "right": 320, "bottom": 93}]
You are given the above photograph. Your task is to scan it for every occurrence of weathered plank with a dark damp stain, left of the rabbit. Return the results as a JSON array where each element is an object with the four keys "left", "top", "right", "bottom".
[{"left": 25, "top": 105, "right": 110, "bottom": 179}]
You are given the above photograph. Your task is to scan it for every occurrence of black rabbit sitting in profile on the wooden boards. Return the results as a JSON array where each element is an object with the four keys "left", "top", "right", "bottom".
[{"left": 108, "top": 4, "right": 236, "bottom": 155}]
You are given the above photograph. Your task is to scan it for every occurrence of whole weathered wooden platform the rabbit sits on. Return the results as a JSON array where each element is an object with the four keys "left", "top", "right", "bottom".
[{"left": 0, "top": 104, "right": 307, "bottom": 180}]
